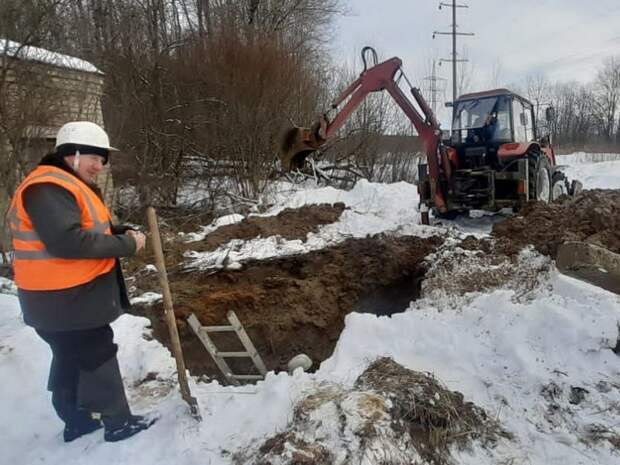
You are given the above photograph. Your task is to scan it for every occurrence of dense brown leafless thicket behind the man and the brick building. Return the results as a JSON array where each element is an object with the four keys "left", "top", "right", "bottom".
[{"left": 0, "top": 0, "right": 344, "bottom": 216}]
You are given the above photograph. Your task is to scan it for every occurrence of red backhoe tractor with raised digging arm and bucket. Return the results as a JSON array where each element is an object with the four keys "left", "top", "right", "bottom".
[{"left": 280, "top": 47, "right": 581, "bottom": 224}]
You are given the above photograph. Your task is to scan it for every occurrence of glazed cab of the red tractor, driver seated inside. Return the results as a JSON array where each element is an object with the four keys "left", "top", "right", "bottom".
[{"left": 449, "top": 89, "right": 536, "bottom": 169}]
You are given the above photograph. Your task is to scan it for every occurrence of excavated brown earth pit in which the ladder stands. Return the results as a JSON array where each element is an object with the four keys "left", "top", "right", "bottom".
[{"left": 136, "top": 236, "right": 442, "bottom": 382}]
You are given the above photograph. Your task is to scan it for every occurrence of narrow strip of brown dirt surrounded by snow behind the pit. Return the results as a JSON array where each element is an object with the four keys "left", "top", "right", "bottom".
[{"left": 192, "top": 202, "right": 345, "bottom": 252}]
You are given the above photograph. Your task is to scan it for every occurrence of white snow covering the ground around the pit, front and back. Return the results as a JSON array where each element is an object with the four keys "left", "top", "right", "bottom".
[{"left": 0, "top": 156, "right": 620, "bottom": 465}]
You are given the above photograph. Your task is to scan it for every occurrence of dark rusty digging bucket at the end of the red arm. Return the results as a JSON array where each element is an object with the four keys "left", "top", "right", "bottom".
[{"left": 280, "top": 117, "right": 327, "bottom": 171}]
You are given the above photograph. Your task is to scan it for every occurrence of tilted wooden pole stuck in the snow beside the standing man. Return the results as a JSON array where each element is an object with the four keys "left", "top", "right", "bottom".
[{"left": 146, "top": 207, "right": 201, "bottom": 421}]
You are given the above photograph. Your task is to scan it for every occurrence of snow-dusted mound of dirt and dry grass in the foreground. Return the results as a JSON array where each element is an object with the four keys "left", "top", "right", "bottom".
[{"left": 234, "top": 358, "right": 510, "bottom": 465}]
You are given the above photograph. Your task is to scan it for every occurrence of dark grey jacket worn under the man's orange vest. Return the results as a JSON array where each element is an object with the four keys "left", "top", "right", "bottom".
[{"left": 18, "top": 156, "right": 135, "bottom": 331}]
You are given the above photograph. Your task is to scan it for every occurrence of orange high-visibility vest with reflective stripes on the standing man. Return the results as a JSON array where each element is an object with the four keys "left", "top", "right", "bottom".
[{"left": 7, "top": 166, "right": 115, "bottom": 291}]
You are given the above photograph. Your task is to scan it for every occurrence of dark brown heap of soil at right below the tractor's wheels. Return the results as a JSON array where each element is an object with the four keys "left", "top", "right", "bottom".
[{"left": 493, "top": 189, "right": 620, "bottom": 258}]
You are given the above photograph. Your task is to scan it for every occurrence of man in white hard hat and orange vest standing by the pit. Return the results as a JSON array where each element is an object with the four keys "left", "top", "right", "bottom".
[{"left": 7, "top": 121, "right": 154, "bottom": 442}]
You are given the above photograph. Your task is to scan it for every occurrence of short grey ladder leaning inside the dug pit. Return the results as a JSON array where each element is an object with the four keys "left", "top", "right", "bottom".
[{"left": 187, "top": 310, "right": 267, "bottom": 386}]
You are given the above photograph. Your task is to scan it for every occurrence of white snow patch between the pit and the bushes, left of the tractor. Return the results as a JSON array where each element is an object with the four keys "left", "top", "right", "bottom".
[{"left": 186, "top": 180, "right": 437, "bottom": 269}]
